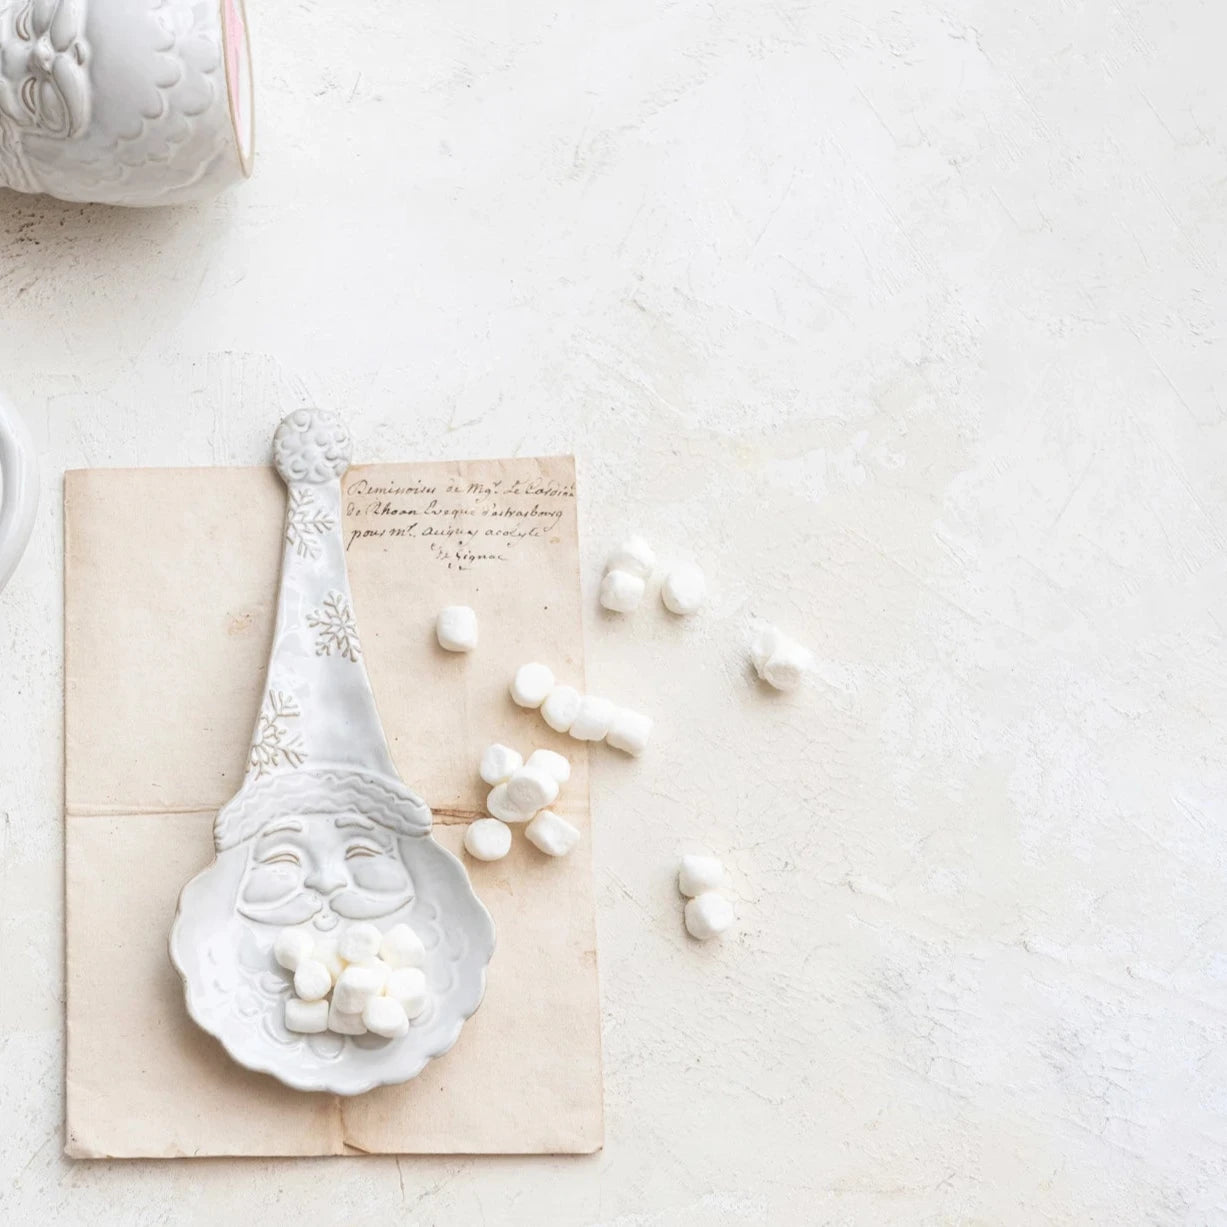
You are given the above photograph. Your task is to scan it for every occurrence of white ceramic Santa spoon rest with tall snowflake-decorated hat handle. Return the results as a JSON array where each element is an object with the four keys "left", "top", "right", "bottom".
[{"left": 171, "top": 410, "right": 494, "bottom": 1094}]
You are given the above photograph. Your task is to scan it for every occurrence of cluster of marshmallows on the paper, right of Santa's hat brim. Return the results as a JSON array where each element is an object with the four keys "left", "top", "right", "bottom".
[{"left": 464, "top": 744, "right": 579, "bottom": 860}]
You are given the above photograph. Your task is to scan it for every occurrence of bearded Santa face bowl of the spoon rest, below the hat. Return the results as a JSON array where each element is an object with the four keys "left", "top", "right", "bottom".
[{"left": 171, "top": 790, "right": 494, "bottom": 1094}]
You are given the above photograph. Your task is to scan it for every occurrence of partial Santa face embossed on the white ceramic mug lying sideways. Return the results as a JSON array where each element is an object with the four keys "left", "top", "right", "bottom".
[{"left": 0, "top": 0, "right": 90, "bottom": 137}]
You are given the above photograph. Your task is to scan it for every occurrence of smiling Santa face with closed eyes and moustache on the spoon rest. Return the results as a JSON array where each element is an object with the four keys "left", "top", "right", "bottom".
[{"left": 237, "top": 812, "right": 413, "bottom": 931}]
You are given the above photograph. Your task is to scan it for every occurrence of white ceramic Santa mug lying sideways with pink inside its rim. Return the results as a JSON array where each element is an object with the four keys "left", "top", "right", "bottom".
[{"left": 0, "top": 0, "right": 254, "bottom": 205}]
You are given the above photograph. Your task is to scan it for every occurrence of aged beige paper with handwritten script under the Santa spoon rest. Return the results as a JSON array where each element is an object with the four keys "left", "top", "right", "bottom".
[{"left": 65, "top": 458, "right": 602, "bottom": 1157}]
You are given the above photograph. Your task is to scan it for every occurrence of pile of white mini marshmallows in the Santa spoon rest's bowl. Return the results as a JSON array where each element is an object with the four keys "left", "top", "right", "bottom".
[{"left": 272, "top": 921, "right": 429, "bottom": 1039}]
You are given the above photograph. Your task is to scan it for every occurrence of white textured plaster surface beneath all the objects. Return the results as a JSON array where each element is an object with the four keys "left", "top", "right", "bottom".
[{"left": 0, "top": 0, "right": 1227, "bottom": 1227}]
